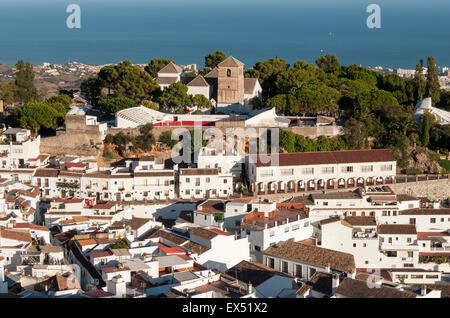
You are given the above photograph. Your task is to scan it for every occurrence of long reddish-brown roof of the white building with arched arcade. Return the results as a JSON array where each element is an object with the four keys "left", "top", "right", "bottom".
[{"left": 256, "top": 149, "right": 396, "bottom": 167}]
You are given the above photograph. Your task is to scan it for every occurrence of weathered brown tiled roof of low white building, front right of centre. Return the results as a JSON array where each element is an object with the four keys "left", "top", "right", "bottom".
[{"left": 264, "top": 241, "right": 355, "bottom": 273}]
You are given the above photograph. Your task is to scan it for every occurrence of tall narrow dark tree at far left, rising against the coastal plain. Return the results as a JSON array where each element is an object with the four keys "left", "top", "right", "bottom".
[{"left": 15, "top": 60, "right": 40, "bottom": 103}]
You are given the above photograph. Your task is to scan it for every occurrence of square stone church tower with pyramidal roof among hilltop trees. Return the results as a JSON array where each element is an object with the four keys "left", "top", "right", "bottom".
[{"left": 217, "top": 56, "right": 245, "bottom": 105}]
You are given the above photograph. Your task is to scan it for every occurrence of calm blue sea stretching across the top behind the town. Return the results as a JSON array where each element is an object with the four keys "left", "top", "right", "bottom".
[{"left": 0, "top": 0, "right": 450, "bottom": 68}]
